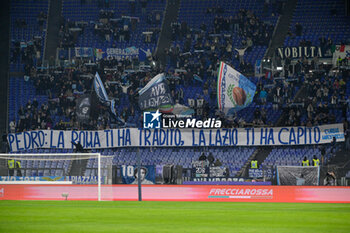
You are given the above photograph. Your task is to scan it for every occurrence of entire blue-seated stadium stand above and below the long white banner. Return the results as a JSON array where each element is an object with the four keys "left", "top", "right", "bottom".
[{"left": 3, "top": 0, "right": 350, "bottom": 186}]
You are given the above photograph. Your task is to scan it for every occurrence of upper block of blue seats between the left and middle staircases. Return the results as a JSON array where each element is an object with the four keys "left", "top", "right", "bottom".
[{"left": 62, "top": 0, "right": 165, "bottom": 51}]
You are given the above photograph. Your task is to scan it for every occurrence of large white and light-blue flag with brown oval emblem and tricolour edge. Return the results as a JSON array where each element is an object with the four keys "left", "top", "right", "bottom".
[{"left": 217, "top": 62, "right": 256, "bottom": 115}]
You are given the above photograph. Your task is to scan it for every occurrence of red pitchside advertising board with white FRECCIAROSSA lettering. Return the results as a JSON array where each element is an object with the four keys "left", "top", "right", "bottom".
[{"left": 0, "top": 184, "right": 350, "bottom": 203}]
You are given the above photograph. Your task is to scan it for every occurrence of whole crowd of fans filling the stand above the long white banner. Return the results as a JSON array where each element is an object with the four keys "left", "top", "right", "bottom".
[{"left": 10, "top": 1, "right": 349, "bottom": 140}]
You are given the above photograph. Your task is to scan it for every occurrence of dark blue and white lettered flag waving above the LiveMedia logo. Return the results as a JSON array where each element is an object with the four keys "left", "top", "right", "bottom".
[{"left": 139, "top": 74, "right": 174, "bottom": 112}]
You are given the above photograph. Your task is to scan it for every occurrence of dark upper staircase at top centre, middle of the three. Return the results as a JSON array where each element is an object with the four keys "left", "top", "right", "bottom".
[{"left": 155, "top": 0, "right": 181, "bottom": 65}]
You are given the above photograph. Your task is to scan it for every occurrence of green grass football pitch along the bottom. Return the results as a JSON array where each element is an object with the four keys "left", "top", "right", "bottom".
[{"left": 0, "top": 201, "right": 350, "bottom": 233}]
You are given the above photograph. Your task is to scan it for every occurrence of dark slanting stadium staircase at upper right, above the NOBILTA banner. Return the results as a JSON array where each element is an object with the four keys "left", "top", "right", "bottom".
[{"left": 266, "top": 0, "right": 297, "bottom": 57}]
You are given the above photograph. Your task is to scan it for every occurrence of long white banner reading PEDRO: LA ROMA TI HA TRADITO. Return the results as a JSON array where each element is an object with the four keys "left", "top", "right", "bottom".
[{"left": 8, "top": 124, "right": 344, "bottom": 152}]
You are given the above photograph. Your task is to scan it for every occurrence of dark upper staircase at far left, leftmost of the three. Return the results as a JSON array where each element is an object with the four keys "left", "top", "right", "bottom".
[{"left": 44, "top": 0, "right": 62, "bottom": 60}]
